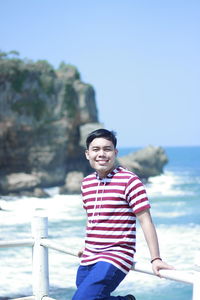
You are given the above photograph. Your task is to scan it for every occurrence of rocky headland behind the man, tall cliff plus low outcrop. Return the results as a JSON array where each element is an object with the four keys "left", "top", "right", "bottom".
[{"left": 0, "top": 52, "right": 166, "bottom": 197}]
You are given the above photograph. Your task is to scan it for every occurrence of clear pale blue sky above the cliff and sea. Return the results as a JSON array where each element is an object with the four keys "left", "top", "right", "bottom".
[{"left": 0, "top": 0, "right": 200, "bottom": 147}]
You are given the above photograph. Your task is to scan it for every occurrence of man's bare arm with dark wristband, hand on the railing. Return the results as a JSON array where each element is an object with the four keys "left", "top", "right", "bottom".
[{"left": 136, "top": 209, "right": 174, "bottom": 276}]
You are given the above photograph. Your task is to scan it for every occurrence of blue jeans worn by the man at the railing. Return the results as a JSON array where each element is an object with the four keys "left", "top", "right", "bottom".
[{"left": 72, "top": 261, "right": 126, "bottom": 300}]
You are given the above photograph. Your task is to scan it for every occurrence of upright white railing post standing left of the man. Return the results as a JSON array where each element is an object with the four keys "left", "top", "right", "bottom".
[{"left": 32, "top": 216, "right": 49, "bottom": 300}]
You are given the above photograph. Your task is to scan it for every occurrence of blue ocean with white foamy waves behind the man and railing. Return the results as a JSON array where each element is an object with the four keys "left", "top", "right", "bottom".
[{"left": 0, "top": 147, "right": 200, "bottom": 300}]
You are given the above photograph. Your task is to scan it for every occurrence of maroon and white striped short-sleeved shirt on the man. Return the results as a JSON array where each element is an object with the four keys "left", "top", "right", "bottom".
[{"left": 81, "top": 167, "right": 150, "bottom": 273}]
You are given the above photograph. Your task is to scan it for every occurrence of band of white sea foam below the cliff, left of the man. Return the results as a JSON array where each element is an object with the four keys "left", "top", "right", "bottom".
[{"left": 0, "top": 195, "right": 85, "bottom": 225}]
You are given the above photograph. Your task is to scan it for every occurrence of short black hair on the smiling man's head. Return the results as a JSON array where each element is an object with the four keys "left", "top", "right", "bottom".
[{"left": 86, "top": 128, "right": 117, "bottom": 149}]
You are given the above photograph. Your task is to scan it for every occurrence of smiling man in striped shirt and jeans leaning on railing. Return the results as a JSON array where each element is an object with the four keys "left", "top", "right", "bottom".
[{"left": 72, "top": 129, "right": 173, "bottom": 300}]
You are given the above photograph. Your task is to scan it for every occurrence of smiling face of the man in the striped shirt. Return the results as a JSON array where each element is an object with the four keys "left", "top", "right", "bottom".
[{"left": 85, "top": 138, "right": 118, "bottom": 178}]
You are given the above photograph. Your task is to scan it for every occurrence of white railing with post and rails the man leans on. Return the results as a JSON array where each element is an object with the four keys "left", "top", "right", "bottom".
[{"left": 0, "top": 216, "right": 200, "bottom": 300}]
